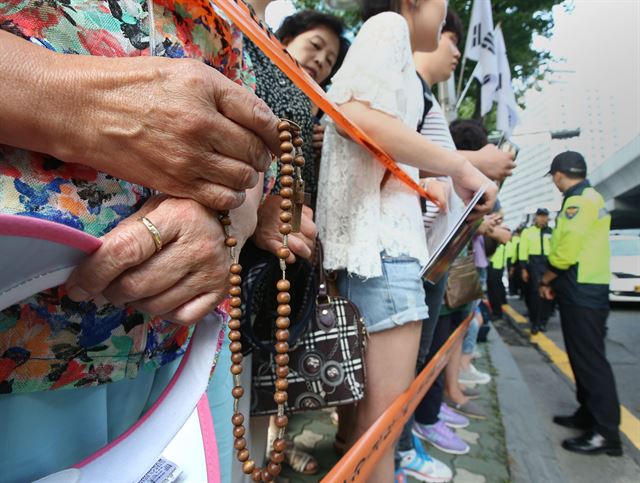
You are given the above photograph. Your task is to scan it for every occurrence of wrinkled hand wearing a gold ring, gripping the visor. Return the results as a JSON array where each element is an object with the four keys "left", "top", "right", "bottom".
[{"left": 66, "top": 196, "right": 230, "bottom": 324}]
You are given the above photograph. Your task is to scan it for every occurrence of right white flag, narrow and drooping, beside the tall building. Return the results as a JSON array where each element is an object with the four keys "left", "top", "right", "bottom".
[{"left": 494, "top": 25, "right": 520, "bottom": 137}]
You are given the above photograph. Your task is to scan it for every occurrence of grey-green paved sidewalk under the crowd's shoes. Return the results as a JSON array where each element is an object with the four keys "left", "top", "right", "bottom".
[{"left": 278, "top": 331, "right": 516, "bottom": 483}]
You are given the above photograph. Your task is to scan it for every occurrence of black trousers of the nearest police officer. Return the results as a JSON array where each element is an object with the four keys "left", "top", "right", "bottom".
[{"left": 559, "top": 306, "right": 620, "bottom": 441}]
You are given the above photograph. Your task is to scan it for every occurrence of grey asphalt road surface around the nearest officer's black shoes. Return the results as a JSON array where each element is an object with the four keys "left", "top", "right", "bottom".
[{"left": 499, "top": 299, "right": 640, "bottom": 483}]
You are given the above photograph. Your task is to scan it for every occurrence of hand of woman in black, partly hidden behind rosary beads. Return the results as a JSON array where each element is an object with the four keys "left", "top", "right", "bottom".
[{"left": 253, "top": 195, "right": 317, "bottom": 263}]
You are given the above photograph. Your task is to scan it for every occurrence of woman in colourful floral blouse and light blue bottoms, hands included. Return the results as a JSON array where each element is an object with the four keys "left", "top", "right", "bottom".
[{"left": 0, "top": 4, "right": 278, "bottom": 482}]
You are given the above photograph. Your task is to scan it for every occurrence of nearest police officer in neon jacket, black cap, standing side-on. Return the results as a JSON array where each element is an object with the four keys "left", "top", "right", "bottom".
[{"left": 540, "top": 151, "right": 622, "bottom": 456}]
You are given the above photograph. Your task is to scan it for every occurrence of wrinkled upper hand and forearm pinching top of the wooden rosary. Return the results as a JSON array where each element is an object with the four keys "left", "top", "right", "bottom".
[{"left": 0, "top": 30, "right": 279, "bottom": 210}]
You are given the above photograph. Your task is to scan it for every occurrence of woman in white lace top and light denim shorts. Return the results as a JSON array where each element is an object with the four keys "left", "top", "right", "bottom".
[{"left": 317, "top": 0, "right": 497, "bottom": 482}]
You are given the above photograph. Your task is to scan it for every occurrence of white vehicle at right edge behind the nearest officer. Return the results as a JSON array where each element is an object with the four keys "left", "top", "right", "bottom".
[{"left": 609, "top": 230, "right": 640, "bottom": 302}]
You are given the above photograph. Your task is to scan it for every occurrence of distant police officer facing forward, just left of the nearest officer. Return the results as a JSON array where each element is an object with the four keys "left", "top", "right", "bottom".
[{"left": 518, "top": 208, "right": 552, "bottom": 335}]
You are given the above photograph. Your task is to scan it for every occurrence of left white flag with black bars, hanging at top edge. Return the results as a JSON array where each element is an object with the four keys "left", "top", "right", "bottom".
[{"left": 464, "top": 0, "right": 498, "bottom": 116}]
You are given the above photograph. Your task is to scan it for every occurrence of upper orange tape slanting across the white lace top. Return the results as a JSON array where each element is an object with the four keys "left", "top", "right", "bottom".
[{"left": 209, "top": 0, "right": 439, "bottom": 205}]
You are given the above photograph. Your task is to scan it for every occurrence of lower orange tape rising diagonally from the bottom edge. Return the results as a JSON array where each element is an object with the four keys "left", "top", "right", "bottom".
[{"left": 321, "top": 314, "right": 473, "bottom": 483}]
